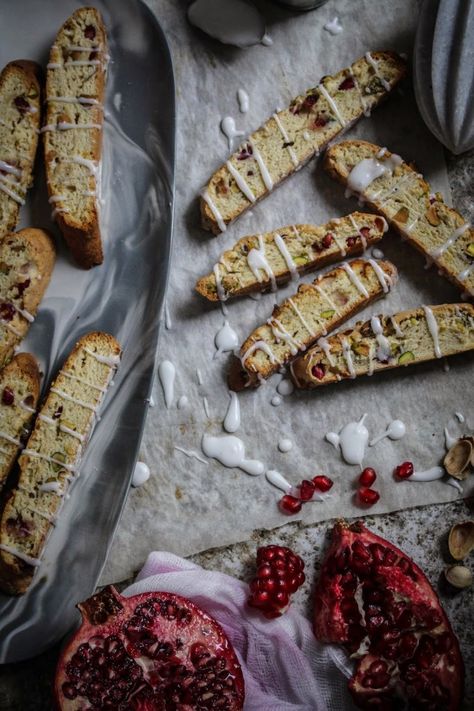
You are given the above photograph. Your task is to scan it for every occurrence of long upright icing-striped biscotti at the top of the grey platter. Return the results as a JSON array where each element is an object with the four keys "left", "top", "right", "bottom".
[{"left": 41, "top": 7, "right": 108, "bottom": 268}]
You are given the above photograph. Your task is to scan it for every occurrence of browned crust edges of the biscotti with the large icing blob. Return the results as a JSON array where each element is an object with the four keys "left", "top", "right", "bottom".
[{"left": 323, "top": 140, "right": 474, "bottom": 297}]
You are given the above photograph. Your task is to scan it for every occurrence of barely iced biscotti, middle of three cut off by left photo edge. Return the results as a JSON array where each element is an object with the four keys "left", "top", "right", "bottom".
[{"left": 0, "top": 227, "right": 56, "bottom": 368}]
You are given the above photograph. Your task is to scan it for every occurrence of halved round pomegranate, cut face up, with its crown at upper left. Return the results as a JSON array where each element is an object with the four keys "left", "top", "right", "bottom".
[{"left": 55, "top": 586, "right": 244, "bottom": 711}]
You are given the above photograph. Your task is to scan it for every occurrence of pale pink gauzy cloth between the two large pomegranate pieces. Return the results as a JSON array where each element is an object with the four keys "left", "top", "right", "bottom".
[{"left": 124, "top": 552, "right": 356, "bottom": 711}]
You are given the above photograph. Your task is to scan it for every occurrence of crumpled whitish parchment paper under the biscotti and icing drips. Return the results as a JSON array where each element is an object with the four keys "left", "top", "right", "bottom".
[{"left": 102, "top": 0, "right": 473, "bottom": 583}]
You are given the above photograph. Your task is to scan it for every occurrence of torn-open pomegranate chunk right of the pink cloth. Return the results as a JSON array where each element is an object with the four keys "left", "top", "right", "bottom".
[{"left": 314, "top": 521, "right": 464, "bottom": 711}]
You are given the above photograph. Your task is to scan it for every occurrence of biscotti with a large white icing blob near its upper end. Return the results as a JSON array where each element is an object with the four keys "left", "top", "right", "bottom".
[{"left": 324, "top": 141, "right": 474, "bottom": 296}]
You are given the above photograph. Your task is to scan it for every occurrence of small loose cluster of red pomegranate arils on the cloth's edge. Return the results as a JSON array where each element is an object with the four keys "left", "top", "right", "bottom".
[{"left": 247, "top": 546, "right": 305, "bottom": 619}]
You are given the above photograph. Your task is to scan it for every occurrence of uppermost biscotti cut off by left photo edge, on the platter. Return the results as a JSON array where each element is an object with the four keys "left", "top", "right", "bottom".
[{"left": 0, "top": 59, "right": 41, "bottom": 237}]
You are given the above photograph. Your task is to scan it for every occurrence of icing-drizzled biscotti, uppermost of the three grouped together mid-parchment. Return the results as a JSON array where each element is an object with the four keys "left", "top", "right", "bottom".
[{"left": 196, "top": 212, "right": 387, "bottom": 301}]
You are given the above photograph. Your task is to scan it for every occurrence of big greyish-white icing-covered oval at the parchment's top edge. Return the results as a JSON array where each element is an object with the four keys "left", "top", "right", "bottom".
[{"left": 188, "top": 0, "right": 266, "bottom": 47}]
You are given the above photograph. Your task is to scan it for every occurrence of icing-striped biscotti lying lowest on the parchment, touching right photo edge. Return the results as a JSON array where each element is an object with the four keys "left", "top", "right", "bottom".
[{"left": 291, "top": 303, "right": 474, "bottom": 389}]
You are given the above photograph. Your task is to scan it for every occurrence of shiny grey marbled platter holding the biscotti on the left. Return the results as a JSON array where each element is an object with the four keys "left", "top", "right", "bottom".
[{"left": 0, "top": 0, "right": 175, "bottom": 663}]
